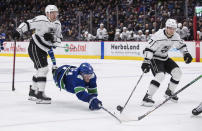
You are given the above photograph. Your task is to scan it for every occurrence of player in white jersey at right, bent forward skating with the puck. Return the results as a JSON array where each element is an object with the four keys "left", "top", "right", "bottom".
[{"left": 141, "top": 19, "right": 192, "bottom": 106}]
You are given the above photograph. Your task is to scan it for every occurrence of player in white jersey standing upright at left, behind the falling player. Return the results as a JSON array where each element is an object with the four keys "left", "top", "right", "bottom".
[{"left": 13, "top": 5, "right": 62, "bottom": 104}]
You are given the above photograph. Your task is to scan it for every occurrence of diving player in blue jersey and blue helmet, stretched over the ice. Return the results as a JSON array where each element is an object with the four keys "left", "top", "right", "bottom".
[{"left": 52, "top": 63, "right": 102, "bottom": 110}]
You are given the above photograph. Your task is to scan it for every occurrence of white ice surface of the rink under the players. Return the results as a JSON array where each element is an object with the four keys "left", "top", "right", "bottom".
[{"left": 0, "top": 56, "right": 202, "bottom": 131}]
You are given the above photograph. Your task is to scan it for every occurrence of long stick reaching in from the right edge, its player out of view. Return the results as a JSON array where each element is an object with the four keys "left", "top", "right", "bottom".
[{"left": 138, "top": 75, "right": 202, "bottom": 120}]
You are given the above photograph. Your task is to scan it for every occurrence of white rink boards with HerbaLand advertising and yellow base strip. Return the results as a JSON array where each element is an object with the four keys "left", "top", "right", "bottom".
[{"left": 0, "top": 41, "right": 202, "bottom": 61}]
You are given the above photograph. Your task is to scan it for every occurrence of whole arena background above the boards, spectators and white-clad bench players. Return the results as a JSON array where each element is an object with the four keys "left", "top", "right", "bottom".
[{"left": 0, "top": 0, "right": 202, "bottom": 41}]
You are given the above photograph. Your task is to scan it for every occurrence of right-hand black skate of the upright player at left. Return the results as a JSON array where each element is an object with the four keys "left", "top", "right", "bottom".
[{"left": 36, "top": 91, "right": 51, "bottom": 104}]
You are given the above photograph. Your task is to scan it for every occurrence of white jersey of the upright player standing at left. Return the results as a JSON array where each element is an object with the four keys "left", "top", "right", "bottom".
[{"left": 16, "top": 15, "right": 62, "bottom": 52}]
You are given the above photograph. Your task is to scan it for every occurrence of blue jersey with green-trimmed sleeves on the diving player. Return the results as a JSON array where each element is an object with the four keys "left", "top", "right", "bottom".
[{"left": 53, "top": 65, "right": 98, "bottom": 102}]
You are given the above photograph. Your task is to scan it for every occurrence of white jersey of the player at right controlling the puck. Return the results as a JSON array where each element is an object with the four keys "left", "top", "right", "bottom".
[{"left": 144, "top": 29, "right": 188, "bottom": 61}]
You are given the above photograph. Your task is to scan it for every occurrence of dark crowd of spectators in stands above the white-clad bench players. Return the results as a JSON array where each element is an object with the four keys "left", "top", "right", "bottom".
[{"left": 0, "top": 0, "right": 199, "bottom": 41}]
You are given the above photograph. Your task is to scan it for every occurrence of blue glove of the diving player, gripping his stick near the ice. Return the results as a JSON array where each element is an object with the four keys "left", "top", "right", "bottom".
[{"left": 89, "top": 97, "right": 102, "bottom": 111}]
